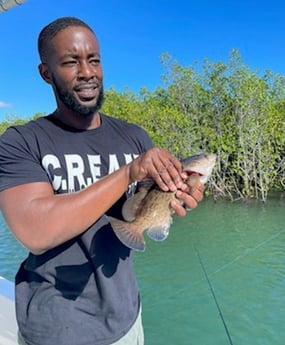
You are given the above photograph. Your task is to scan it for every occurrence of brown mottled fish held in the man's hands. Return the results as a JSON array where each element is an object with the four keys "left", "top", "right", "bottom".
[{"left": 108, "top": 153, "right": 216, "bottom": 252}]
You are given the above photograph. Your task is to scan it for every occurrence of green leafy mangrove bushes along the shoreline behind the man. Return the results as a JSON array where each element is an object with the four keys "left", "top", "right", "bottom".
[{"left": 0, "top": 49, "right": 285, "bottom": 202}]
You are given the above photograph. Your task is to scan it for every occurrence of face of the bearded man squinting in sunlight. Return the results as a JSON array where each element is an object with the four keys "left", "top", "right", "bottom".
[{"left": 43, "top": 26, "right": 104, "bottom": 116}]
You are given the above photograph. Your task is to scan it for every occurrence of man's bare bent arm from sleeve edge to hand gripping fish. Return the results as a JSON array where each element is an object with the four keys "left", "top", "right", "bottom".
[{"left": 0, "top": 148, "right": 199, "bottom": 254}]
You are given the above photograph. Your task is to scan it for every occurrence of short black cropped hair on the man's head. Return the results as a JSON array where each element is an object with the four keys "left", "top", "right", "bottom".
[{"left": 38, "top": 17, "right": 95, "bottom": 62}]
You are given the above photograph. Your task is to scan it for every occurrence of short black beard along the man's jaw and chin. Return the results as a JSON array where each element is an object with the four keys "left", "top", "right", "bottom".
[{"left": 52, "top": 78, "right": 104, "bottom": 117}]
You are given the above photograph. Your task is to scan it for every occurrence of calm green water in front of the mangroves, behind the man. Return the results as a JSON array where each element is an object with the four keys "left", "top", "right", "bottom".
[{"left": 0, "top": 194, "right": 285, "bottom": 345}]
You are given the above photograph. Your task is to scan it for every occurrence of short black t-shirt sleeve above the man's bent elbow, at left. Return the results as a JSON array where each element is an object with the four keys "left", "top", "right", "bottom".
[{"left": 0, "top": 127, "right": 49, "bottom": 191}]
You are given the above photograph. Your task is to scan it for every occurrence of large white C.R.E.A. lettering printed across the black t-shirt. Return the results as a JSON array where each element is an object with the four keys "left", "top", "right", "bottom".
[{"left": 42, "top": 153, "right": 138, "bottom": 194}]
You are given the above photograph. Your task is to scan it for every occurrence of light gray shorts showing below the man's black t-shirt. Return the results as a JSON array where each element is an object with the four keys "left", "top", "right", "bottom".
[{"left": 18, "top": 310, "right": 144, "bottom": 345}]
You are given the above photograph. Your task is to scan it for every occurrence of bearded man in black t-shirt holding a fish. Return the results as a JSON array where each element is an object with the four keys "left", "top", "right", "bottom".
[{"left": 0, "top": 17, "right": 203, "bottom": 345}]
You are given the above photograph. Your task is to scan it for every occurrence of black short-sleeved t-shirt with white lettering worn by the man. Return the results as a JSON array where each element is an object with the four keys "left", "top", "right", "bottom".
[{"left": 0, "top": 114, "right": 152, "bottom": 345}]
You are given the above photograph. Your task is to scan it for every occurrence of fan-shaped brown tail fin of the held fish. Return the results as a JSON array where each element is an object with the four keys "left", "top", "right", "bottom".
[{"left": 108, "top": 217, "right": 145, "bottom": 252}]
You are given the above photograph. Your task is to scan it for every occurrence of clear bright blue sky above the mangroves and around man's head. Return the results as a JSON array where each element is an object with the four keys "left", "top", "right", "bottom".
[{"left": 0, "top": 0, "right": 285, "bottom": 120}]
